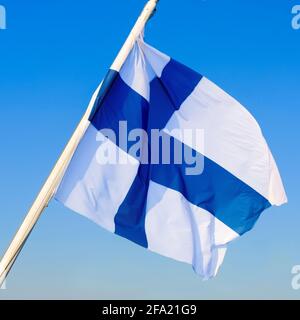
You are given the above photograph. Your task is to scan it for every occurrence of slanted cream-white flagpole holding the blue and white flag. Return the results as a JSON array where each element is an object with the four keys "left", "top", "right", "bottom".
[{"left": 0, "top": 0, "right": 158, "bottom": 286}]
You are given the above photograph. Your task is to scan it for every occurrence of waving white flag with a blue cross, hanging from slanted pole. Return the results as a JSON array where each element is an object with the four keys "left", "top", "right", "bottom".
[{"left": 56, "top": 38, "right": 287, "bottom": 278}]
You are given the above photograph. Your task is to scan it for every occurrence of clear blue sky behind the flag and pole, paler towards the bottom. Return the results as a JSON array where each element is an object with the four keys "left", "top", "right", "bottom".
[{"left": 0, "top": 0, "right": 300, "bottom": 299}]
